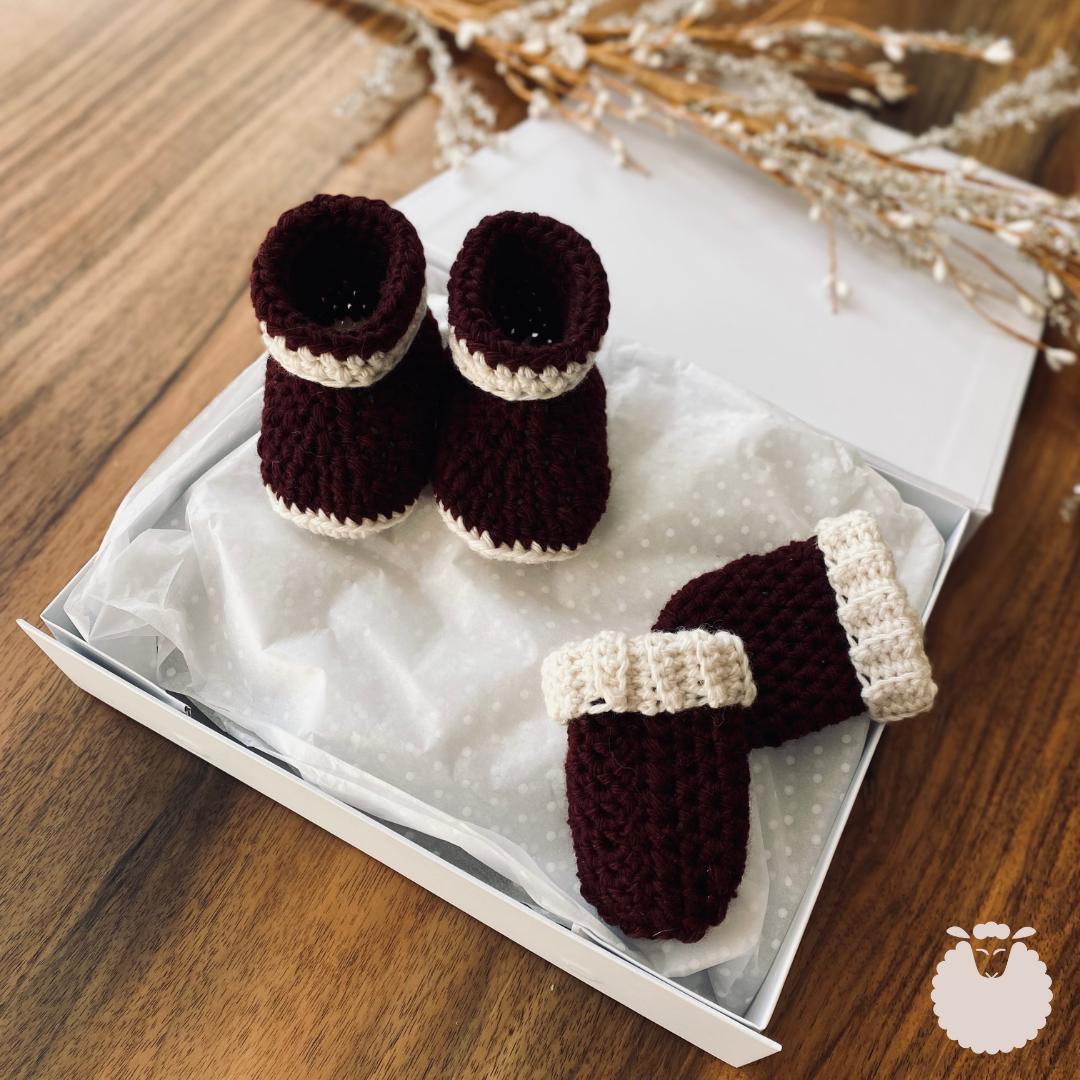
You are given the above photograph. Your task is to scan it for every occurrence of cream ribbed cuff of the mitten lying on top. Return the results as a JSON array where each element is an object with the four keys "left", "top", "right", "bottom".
[{"left": 540, "top": 630, "right": 757, "bottom": 724}]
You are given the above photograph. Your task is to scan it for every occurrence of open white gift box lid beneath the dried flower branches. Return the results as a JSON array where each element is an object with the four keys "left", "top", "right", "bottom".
[{"left": 397, "top": 121, "right": 1040, "bottom": 517}]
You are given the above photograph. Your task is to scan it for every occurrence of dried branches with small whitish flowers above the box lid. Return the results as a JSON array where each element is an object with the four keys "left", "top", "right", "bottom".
[{"left": 341, "top": 0, "right": 1080, "bottom": 370}]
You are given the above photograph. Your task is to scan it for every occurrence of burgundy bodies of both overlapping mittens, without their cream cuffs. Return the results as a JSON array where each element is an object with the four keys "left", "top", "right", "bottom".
[{"left": 566, "top": 539, "right": 865, "bottom": 942}]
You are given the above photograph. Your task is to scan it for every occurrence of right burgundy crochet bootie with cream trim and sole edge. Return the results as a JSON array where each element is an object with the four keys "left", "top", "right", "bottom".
[{"left": 432, "top": 212, "right": 611, "bottom": 563}]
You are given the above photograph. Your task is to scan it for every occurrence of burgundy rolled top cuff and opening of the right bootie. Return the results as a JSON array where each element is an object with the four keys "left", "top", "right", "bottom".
[{"left": 449, "top": 211, "right": 610, "bottom": 373}]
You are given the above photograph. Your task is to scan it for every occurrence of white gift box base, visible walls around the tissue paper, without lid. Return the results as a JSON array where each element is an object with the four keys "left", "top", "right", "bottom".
[{"left": 19, "top": 470, "right": 971, "bottom": 1066}]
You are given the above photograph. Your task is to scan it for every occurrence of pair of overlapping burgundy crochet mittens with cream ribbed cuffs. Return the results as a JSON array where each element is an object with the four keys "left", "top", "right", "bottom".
[{"left": 543, "top": 511, "right": 936, "bottom": 942}]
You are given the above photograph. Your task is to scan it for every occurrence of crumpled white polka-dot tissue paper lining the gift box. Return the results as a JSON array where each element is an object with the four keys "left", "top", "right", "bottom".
[{"left": 66, "top": 328, "right": 943, "bottom": 1013}]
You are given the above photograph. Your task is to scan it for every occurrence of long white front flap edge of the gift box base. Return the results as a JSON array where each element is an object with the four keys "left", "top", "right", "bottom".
[{"left": 18, "top": 619, "right": 781, "bottom": 1067}]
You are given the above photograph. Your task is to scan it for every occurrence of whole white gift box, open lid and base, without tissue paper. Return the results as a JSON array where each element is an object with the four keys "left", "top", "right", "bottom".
[{"left": 22, "top": 116, "right": 1032, "bottom": 1065}]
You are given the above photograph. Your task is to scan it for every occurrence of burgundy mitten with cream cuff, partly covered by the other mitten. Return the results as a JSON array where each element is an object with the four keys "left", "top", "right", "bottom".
[{"left": 652, "top": 510, "right": 937, "bottom": 748}]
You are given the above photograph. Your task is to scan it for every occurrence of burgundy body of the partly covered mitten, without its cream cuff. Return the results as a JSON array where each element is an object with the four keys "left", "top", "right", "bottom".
[{"left": 652, "top": 538, "right": 866, "bottom": 748}]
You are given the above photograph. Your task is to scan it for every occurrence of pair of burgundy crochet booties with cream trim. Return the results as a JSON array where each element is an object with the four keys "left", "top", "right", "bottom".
[{"left": 252, "top": 195, "right": 611, "bottom": 563}]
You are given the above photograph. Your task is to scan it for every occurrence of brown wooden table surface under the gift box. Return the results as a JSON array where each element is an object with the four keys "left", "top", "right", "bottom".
[{"left": 0, "top": 0, "right": 1080, "bottom": 1080}]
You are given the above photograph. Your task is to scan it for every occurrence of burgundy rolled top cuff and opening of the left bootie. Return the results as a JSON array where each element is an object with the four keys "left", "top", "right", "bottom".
[{"left": 252, "top": 195, "right": 426, "bottom": 361}]
